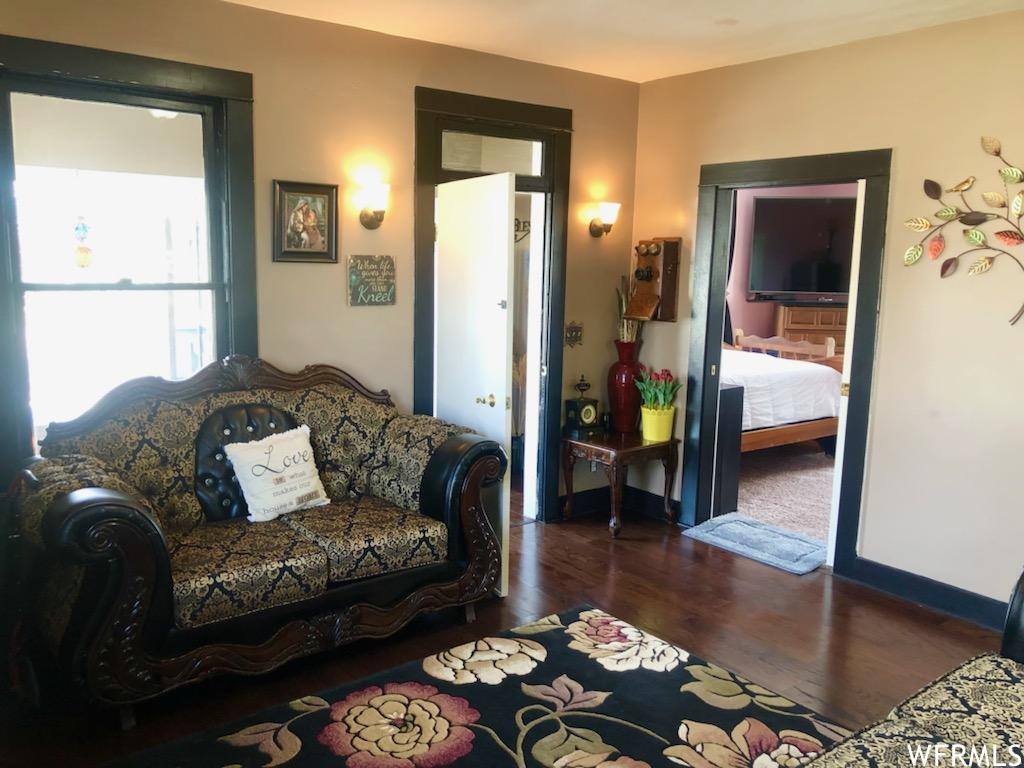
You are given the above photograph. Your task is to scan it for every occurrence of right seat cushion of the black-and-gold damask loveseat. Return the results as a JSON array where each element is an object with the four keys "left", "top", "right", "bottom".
[{"left": 280, "top": 496, "right": 447, "bottom": 583}]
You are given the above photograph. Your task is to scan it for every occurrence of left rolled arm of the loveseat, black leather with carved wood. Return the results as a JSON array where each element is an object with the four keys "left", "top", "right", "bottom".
[{"left": 18, "top": 456, "right": 173, "bottom": 703}]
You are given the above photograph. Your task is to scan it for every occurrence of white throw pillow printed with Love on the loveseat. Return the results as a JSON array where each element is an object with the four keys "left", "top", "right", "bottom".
[{"left": 224, "top": 424, "right": 331, "bottom": 522}]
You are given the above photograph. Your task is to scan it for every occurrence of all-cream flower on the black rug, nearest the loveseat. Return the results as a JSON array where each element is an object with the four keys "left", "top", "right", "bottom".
[{"left": 423, "top": 637, "right": 548, "bottom": 685}]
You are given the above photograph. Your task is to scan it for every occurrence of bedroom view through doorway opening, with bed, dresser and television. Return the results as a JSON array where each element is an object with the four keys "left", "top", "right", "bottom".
[{"left": 714, "top": 181, "right": 861, "bottom": 548}]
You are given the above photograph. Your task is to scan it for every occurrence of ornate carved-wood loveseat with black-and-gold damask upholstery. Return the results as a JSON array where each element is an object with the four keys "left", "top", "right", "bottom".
[{"left": 13, "top": 356, "right": 506, "bottom": 716}]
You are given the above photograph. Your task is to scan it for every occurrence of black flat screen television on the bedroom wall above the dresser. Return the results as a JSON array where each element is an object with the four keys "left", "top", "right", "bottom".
[{"left": 748, "top": 198, "right": 857, "bottom": 303}]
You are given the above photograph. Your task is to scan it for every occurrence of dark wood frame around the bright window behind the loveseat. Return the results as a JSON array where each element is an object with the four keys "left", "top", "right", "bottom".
[{"left": 0, "top": 35, "right": 258, "bottom": 481}]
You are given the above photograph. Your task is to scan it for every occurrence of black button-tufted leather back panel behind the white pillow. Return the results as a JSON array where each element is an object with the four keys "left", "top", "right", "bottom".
[{"left": 196, "top": 402, "right": 298, "bottom": 522}]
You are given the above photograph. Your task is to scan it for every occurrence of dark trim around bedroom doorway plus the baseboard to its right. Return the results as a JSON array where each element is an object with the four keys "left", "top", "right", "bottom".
[{"left": 682, "top": 150, "right": 1006, "bottom": 628}]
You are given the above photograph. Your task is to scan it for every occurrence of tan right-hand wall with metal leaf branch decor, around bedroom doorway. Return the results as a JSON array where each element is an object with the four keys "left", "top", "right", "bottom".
[{"left": 634, "top": 13, "right": 1024, "bottom": 600}]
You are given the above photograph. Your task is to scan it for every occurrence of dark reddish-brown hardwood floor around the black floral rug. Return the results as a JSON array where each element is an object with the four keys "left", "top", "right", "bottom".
[{"left": 0, "top": 507, "right": 991, "bottom": 766}]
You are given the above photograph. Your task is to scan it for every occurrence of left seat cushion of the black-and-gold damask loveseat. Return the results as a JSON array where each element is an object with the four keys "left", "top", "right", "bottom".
[{"left": 170, "top": 518, "right": 328, "bottom": 628}]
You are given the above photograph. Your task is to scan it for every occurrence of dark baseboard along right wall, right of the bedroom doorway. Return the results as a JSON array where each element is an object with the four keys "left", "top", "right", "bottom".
[{"left": 833, "top": 557, "right": 1007, "bottom": 631}]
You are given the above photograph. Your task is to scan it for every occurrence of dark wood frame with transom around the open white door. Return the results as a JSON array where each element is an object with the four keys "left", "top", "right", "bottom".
[{"left": 413, "top": 87, "right": 572, "bottom": 521}]
